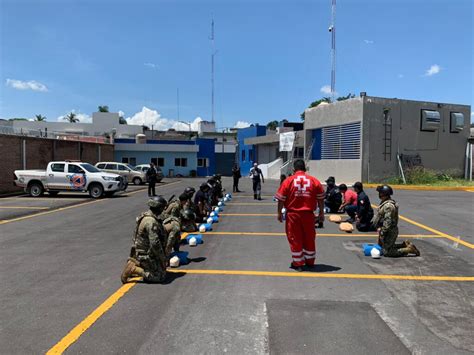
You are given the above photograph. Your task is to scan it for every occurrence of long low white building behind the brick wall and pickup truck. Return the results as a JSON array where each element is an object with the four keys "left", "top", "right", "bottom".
[{"left": 13, "top": 112, "right": 143, "bottom": 138}]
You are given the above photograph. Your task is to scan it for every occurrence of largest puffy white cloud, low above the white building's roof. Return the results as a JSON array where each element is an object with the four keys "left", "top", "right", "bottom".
[{"left": 126, "top": 106, "right": 203, "bottom": 131}]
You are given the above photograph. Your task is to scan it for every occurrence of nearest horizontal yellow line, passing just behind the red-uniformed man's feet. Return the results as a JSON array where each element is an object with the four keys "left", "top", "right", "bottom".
[{"left": 168, "top": 269, "right": 474, "bottom": 282}]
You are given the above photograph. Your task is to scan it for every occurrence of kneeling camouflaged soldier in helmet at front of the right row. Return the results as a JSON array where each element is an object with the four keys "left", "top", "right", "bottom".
[{"left": 373, "top": 185, "right": 420, "bottom": 258}]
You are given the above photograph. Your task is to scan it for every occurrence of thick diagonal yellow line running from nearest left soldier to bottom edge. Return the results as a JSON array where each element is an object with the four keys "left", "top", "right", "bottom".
[{"left": 46, "top": 282, "right": 136, "bottom": 355}]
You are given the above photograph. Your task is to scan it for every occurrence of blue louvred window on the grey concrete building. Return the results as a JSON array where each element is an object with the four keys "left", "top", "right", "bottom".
[{"left": 321, "top": 122, "right": 360, "bottom": 159}]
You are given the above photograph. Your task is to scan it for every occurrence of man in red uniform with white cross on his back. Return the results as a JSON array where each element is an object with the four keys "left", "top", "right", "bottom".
[{"left": 275, "top": 159, "right": 325, "bottom": 271}]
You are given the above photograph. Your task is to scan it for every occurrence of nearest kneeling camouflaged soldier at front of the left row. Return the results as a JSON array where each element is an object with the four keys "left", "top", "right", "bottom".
[{"left": 121, "top": 196, "right": 167, "bottom": 283}]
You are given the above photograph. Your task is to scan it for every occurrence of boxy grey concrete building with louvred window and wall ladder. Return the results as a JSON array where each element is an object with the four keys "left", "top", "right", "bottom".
[{"left": 304, "top": 95, "right": 471, "bottom": 183}]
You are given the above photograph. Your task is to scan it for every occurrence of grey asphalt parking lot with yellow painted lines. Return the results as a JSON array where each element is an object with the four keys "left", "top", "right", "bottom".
[{"left": 0, "top": 179, "right": 474, "bottom": 354}]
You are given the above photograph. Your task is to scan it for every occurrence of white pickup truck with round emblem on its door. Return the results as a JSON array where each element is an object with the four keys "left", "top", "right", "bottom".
[{"left": 14, "top": 160, "right": 127, "bottom": 198}]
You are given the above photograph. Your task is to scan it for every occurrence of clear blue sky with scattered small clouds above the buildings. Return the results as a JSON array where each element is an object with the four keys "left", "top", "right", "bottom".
[{"left": 0, "top": 0, "right": 474, "bottom": 127}]
